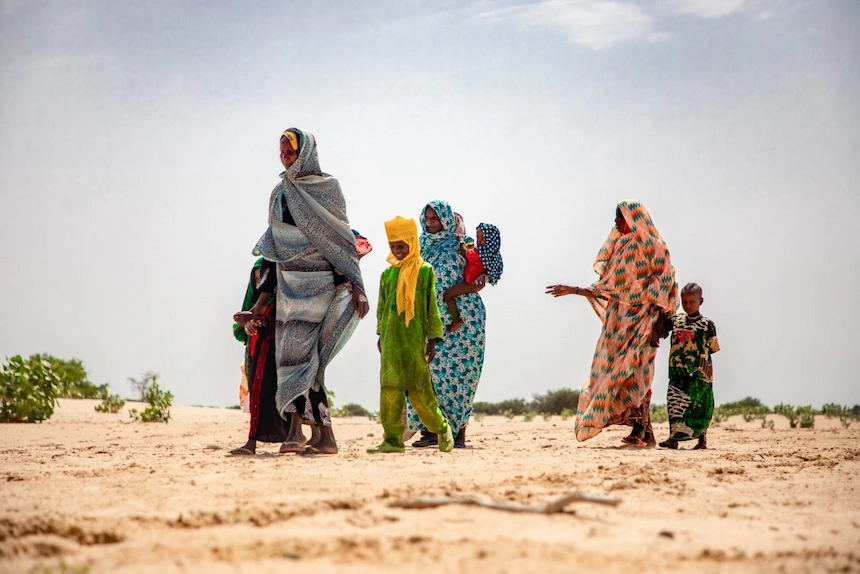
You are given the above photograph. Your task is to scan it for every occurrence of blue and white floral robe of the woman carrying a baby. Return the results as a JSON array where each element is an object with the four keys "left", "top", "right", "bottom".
[{"left": 407, "top": 200, "right": 487, "bottom": 435}]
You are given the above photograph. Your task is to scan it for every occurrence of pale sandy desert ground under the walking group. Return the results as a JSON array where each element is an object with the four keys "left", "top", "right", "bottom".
[{"left": 0, "top": 401, "right": 860, "bottom": 574}]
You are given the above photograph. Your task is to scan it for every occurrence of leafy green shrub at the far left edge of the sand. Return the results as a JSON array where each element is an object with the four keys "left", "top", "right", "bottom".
[{"left": 0, "top": 355, "right": 60, "bottom": 423}]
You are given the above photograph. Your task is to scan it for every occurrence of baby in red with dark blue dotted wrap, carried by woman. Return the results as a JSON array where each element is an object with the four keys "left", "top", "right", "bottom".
[{"left": 442, "top": 223, "right": 504, "bottom": 333}]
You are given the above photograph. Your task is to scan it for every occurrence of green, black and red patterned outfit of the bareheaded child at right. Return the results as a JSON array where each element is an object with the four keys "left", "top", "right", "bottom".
[{"left": 666, "top": 313, "right": 720, "bottom": 441}]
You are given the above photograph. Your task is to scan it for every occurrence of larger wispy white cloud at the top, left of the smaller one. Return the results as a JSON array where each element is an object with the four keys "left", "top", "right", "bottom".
[{"left": 479, "top": 0, "right": 665, "bottom": 50}]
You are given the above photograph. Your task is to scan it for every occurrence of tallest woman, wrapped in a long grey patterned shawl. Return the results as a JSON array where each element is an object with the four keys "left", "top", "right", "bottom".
[{"left": 254, "top": 128, "right": 369, "bottom": 454}]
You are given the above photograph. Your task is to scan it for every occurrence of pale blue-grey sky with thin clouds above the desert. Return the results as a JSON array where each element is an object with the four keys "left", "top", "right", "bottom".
[{"left": 0, "top": 0, "right": 860, "bottom": 409}]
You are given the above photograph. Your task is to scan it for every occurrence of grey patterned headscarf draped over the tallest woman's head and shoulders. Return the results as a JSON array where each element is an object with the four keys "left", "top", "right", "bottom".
[{"left": 255, "top": 128, "right": 364, "bottom": 291}]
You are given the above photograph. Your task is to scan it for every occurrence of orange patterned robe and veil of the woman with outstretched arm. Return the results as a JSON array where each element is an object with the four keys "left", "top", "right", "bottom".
[{"left": 574, "top": 200, "right": 678, "bottom": 441}]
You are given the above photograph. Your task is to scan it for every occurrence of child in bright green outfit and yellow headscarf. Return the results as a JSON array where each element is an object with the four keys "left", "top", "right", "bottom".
[{"left": 367, "top": 216, "right": 454, "bottom": 453}]
